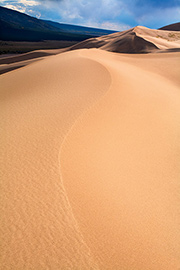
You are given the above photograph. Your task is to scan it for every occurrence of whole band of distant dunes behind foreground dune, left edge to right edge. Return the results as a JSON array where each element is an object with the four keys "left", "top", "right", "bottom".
[{"left": 0, "top": 24, "right": 180, "bottom": 74}]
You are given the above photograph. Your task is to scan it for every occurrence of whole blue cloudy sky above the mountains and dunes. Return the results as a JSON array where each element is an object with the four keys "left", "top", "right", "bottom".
[{"left": 0, "top": 0, "right": 180, "bottom": 31}]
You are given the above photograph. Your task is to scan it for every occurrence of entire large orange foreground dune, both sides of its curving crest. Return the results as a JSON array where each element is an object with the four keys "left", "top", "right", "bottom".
[{"left": 0, "top": 49, "right": 180, "bottom": 270}]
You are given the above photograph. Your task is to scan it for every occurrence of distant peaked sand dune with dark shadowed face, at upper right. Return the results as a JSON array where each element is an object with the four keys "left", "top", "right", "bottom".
[{"left": 68, "top": 26, "right": 180, "bottom": 53}]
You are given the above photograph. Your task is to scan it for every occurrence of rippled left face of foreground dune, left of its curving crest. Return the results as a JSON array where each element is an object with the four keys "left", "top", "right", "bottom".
[{"left": 0, "top": 51, "right": 111, "bottom": 270}]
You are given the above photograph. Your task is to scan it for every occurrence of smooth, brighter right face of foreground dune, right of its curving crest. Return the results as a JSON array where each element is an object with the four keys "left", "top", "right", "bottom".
[{"left": 60, "top": 50, "right": 180, "bottom": 270}]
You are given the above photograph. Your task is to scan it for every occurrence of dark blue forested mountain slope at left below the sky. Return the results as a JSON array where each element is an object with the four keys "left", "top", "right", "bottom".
[{"left": 0, "top": 7, "right": 115, "bottom": 41}]
